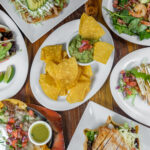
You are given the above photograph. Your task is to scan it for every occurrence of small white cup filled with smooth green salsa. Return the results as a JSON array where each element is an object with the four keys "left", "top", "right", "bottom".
[{"left": 28, "top": 121, "right": 52, "bottom": 146}]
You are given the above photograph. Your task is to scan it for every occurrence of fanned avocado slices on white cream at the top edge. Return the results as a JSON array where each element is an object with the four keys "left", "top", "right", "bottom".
[{"left": 26, "top": 0, "right": 47, "bottom": 11}]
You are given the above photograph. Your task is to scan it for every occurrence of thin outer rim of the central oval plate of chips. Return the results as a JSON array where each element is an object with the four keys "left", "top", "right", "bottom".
[{"left": 30, "top": 19, "right": 115, "bottom": 111}]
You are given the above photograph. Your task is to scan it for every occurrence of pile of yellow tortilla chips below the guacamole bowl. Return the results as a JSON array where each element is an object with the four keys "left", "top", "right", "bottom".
[{"left": 39, "top": 45, "right": 93, "bottom": 103}]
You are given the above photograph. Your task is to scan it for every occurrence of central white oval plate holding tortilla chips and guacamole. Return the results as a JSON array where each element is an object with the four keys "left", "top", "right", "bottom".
[{"left": 30, "top": 20, "right": 115, "bottom": 111}]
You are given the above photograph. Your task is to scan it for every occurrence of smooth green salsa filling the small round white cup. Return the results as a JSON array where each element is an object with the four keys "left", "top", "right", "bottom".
[{"left": 31, "top": 124, "right": 49, "bottom": 143}]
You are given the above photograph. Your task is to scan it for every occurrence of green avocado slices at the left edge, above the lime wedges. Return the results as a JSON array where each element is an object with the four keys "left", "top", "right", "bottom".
[{"left": 0, "top": 42, "right": 12, "bottom": 60}]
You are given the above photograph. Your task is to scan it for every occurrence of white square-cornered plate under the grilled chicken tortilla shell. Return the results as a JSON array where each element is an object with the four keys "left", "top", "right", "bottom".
[{"left": 67, "top": 102, "right": 150, "bottom": 150}]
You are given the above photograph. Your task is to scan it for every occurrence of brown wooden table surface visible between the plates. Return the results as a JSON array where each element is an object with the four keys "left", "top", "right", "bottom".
[{"left": 0, "top": 0, "right": 145, "bottom": 148}]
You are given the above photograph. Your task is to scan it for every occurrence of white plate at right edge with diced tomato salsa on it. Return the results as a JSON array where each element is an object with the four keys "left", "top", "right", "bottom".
[{"left": 110, "top": 48, "right": 150, "bottom": 126}]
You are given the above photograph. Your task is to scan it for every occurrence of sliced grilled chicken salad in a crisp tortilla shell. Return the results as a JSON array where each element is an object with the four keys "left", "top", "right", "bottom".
[{"left": 84, "top": 116, "right": 140, "bottom": 150}]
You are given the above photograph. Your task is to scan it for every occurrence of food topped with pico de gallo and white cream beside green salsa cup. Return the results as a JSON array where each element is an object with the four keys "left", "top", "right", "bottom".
[{"left": 0, "top": 99, "right": 50, "bottom": 150}]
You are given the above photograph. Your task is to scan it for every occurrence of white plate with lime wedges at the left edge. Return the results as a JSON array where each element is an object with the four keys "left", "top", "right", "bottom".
[{"left": 0, "top": 11, "right": 28, "bottom": 100}]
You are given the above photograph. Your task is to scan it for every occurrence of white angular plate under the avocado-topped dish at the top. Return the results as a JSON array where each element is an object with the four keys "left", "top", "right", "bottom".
[{"left": 0, "top": 0, "right": 87, "bottom": 43}]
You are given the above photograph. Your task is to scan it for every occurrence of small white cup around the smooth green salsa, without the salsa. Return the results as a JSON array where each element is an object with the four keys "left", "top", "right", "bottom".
[{"left": 28, "top": 121, "right": 52, "bottom": 146}]
